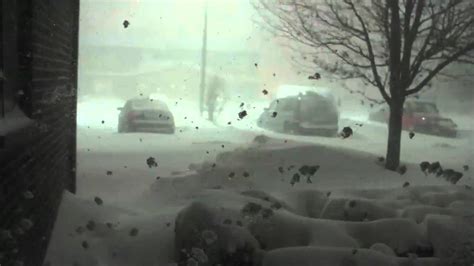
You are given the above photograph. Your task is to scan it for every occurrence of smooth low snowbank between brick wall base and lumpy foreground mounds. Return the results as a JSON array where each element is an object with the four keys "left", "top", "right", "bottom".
[{"left": 45, "top": 193, "right": 178, "bottom": 266}]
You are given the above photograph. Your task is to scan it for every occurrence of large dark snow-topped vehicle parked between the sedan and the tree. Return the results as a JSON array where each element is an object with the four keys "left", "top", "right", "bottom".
[{"left": 257, "top": 91, "right": 339, "bottom": 136}]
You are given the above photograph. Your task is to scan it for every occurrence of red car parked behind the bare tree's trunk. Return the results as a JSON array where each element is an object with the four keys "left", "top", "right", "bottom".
[{"left": 369, "top": 100, "right": 457, "bottom": 137}]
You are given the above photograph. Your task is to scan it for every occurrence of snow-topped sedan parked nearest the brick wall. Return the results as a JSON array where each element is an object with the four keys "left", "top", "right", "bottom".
[{"left": 118, "top": 98, "right": 175, "bottom": 134}]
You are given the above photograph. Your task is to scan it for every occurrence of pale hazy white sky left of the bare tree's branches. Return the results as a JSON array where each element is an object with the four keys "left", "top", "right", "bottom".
[{"left": 80, "top": 0, "right": 268, "bottom": 50}]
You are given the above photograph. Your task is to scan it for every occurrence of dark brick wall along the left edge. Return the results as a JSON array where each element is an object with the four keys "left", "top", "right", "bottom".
[{"left": 0, "top": 0, "right": 79, "bottom": 266}]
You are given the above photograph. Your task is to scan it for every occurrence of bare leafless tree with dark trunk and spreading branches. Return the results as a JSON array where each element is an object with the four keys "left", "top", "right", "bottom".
[{"left": 255, "top": 0, "right": 474, "bottom": 170}]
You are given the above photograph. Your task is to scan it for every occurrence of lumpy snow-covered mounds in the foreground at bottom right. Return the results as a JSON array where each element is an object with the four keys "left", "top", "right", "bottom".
[{"left": 175, "top": 187, "right": 474, "bottom": 265}]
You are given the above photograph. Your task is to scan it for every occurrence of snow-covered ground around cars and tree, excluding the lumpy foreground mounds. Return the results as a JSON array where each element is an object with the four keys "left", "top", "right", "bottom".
[{"left": 46, "top": 99, "right": 474, "bottom": 266}]
